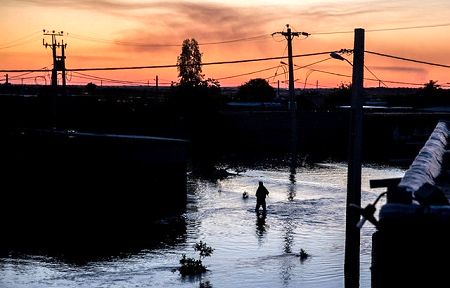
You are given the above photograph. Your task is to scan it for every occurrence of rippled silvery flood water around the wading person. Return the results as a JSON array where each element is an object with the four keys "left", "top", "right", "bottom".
[{"left": 0, "top": 162, "right": 404, "bottom": 288}]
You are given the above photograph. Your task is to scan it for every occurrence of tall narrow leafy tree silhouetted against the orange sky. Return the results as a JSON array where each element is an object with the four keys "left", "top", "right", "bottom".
[{"left": 177, "top": 38, "right": 204, "bottom": 87}]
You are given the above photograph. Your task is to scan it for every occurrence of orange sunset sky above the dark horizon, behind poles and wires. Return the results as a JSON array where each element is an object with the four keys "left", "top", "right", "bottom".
[{"left": 0, "top": 0, "right": 450, "bottom": 88}]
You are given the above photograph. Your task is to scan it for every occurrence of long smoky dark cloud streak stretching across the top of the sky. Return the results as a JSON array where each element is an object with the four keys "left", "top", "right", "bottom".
[{"left": 10, "top": 0, "right": 420, "bottom": 51}]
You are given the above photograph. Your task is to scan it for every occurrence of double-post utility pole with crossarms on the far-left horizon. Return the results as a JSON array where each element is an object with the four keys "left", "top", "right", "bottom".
[{"left": 42, "top": 29, "right": 67, "bottom": 89}]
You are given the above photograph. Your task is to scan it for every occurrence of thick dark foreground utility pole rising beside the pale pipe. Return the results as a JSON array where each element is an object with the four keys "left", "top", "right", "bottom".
[{"left": 344, "top": 28, "right": 364, "bottom": 288}]
